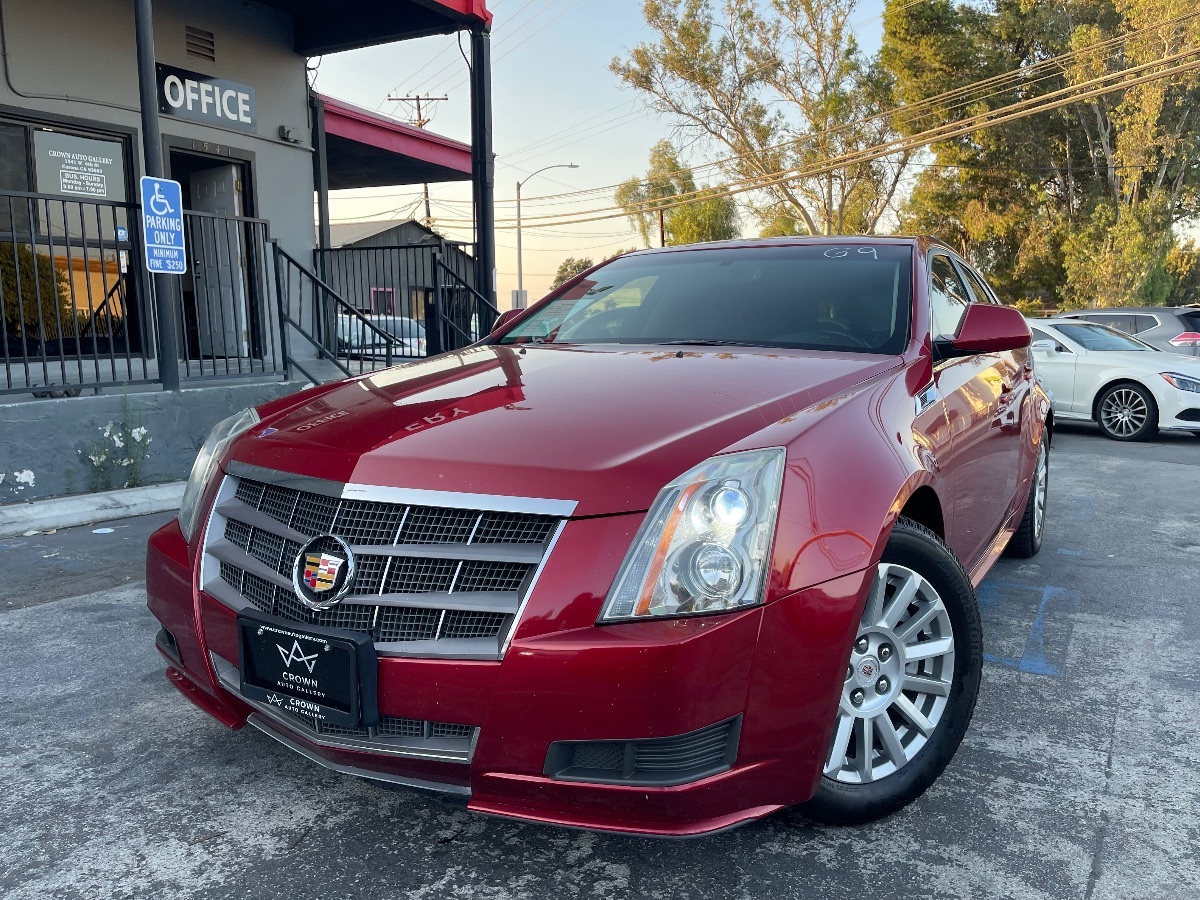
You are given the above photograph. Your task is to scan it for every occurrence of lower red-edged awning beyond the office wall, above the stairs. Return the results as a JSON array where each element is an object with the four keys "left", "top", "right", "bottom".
[{"left": 320, "top": 95, "right": 472, "bottom": 191}]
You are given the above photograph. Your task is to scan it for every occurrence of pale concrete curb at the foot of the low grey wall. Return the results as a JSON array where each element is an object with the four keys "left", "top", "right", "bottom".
[{"left": 0, "top": 481, "right": 187, "bottom": 538}]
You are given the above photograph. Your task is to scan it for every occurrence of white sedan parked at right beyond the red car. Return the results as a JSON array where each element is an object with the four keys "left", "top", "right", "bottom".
[{"left": 1030, "top": 318, "right": 1200, "bottom": 440}]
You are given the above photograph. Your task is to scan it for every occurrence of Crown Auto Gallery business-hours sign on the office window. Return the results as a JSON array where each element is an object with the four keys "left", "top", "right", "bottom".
[{"left": 34, "top": 131, "right": 125, "bottom": 202}]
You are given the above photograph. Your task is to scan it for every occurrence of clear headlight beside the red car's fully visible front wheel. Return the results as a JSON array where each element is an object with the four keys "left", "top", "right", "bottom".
[{"left": 600, "top": 448, "right": 785, "bottom": 622}]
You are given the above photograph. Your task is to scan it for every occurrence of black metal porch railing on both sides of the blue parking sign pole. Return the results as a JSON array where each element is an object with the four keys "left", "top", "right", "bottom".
[{"left": 0, "top": 191, "right": 286, "bottom": 397}]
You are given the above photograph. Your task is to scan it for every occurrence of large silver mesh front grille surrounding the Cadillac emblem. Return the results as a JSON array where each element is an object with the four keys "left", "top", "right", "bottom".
[{"left": 202, "top": 474, "right": 562, "bottom": 659}]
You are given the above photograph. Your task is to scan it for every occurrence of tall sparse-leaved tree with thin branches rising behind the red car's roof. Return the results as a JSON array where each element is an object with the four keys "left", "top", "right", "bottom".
[{"left": 611, "top": 0, "right": 907, "bottom": 234}]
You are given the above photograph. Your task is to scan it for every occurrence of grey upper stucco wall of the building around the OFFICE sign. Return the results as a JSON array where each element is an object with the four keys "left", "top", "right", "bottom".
[{"left": 0, "top": 0, "right": 314, "bottom": 262}]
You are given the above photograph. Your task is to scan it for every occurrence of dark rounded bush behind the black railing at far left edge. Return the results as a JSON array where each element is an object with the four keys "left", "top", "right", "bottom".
[{"left": 0, "top": 242, "right": 76, "bottom": 341}]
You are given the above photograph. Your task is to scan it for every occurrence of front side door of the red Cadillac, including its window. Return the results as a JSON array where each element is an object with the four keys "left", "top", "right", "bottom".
[{"left": 929, "top": 251, "right": 1020, "bottom": 568}]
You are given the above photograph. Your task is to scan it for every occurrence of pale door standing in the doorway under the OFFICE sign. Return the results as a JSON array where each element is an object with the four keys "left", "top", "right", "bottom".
[{"left": 188, "top": 163, "right": 251, "bottom": 358}]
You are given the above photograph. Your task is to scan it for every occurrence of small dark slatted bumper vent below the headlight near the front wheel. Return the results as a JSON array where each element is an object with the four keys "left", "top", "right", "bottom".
[{"left": 545, "top": 715, "right": 742, "bottom": 787}]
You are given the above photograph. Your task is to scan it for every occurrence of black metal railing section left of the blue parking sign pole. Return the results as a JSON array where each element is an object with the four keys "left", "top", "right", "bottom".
[{"left": 0, "top": 191, "right": 156, "bottom": 396}]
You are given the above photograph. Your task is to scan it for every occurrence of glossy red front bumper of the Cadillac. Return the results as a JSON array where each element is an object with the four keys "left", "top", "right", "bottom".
[{"left": 148, "top": 516, "right": 866, "bottom": 836}]
